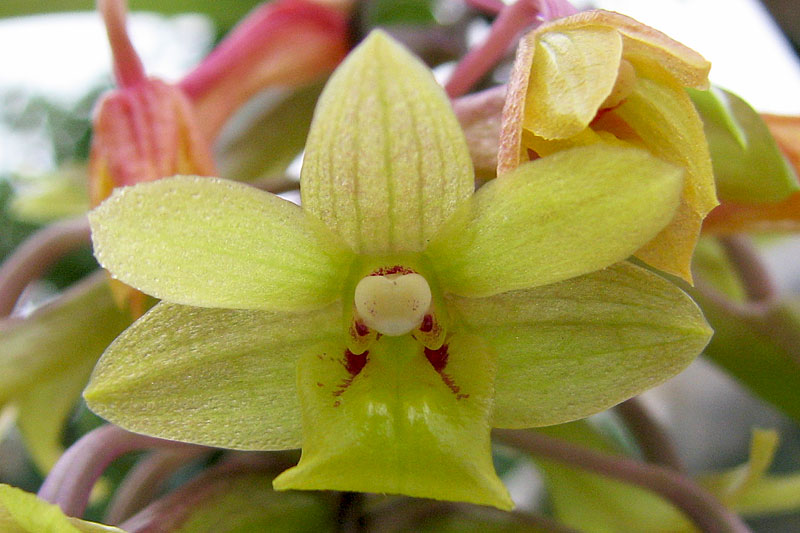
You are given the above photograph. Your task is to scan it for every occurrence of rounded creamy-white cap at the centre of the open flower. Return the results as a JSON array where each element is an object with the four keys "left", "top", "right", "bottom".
[{"left": 354, "top": 272, "right": 431, "bottom": 337}]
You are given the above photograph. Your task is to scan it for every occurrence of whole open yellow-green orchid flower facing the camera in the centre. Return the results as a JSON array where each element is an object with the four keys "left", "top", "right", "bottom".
[{"left": 85, "top": 32, "right": 709, "bottom": 509}]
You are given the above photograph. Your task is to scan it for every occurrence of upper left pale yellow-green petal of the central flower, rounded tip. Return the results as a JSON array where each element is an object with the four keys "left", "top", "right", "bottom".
[{"left": 89, "top": 176, "right": 352, "bottom": 311}]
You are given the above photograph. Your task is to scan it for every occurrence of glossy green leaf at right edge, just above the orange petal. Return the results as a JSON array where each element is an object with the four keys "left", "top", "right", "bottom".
[{"left": 689, "top": 87, "right": 800, "bottom": 203}]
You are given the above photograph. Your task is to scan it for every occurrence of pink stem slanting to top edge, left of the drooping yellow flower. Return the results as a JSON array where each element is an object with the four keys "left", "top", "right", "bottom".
[{"left": 445, "top": 0, "right": 577, "bottom": 98}]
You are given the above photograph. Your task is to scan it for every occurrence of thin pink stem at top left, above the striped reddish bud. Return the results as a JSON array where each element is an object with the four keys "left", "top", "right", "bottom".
[{"left": 97, "top": 0, "right": 146, "bottom": 87}]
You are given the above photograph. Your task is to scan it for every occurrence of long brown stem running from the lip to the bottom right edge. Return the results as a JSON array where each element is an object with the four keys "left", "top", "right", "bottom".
[{"left": 494, "top": 429, "right": 750, "bottom": 533}]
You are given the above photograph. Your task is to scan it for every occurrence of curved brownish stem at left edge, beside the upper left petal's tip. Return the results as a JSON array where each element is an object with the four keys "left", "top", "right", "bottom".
[{"left": 0, "top": 216, "right": 90, "bottom": 318}]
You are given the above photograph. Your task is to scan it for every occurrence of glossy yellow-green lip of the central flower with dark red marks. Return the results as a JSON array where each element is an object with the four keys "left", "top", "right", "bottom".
[{"left": 274, "top": 334, "right": 513, "bottom": 509}]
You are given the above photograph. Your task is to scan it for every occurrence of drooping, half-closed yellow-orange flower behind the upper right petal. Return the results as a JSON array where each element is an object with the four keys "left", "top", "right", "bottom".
[{"left": 498, "top": 10, "right": 717, "bottom": 281}]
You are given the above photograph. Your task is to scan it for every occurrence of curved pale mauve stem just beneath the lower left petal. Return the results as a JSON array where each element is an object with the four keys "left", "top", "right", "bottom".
[{"left": 38, "top": 424, "right": 205, "bottom": 516}]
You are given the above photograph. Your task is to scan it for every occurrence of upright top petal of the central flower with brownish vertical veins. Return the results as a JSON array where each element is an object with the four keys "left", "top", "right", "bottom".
[{"left": 301, "top": 31, "right": 474, "bottom": 254}]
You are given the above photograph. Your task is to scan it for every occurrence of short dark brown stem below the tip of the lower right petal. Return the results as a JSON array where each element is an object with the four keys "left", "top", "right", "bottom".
[{"left": 616, "top": 397, "right": 686, "bottom": 472}]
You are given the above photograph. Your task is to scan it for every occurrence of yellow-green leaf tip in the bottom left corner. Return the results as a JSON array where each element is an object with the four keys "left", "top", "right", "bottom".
[{"left": 0, "top": 484, "right": 125, "bottom": 533}]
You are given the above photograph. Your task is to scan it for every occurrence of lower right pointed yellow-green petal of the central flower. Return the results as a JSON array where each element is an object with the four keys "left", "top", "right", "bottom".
[{"left": 448, "top": 263, "right": 711, "bottom": 428}]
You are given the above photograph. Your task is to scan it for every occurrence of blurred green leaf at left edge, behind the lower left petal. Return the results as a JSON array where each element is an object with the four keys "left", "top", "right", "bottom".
[{"left": 0, "top": 274, "right": 130, "bottom": 472}]
